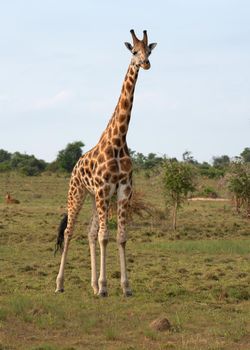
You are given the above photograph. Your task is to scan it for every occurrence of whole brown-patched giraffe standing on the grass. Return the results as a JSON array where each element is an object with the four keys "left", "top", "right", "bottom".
[{"left": 55, "top": 29, "right": 156, "bottom": 297}]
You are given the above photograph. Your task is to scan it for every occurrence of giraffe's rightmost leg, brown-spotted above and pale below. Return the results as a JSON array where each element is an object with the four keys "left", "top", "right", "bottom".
[{"left": 117, "top": 185, "right": 132, "bottom": 296}]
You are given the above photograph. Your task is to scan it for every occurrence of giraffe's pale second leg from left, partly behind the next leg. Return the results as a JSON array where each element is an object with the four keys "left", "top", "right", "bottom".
[{"left": 88, "top": 198, "right": 99, "bottom": 295}]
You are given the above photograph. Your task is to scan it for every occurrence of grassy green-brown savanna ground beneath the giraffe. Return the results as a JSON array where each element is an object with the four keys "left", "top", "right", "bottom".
[{"left": 0, "top": 173, "right": 250, "bottom": 350}]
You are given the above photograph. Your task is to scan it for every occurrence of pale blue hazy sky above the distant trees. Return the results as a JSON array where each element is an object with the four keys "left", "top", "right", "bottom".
[{"left": 0, "top": 0, "right": 250, "bottom": 162}]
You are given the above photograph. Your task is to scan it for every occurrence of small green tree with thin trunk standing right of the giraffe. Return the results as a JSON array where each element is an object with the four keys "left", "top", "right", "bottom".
[{"left": 163, "top": 160, "right": 196, "bottom": 230}]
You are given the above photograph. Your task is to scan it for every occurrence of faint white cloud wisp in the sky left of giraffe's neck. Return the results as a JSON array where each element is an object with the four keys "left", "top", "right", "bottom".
[{"left": 32, "top": 90, "right": 73, "bottom": 109}]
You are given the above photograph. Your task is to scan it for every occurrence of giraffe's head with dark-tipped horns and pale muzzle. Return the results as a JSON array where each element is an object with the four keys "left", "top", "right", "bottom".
[{"left": 125, "top": 29, "right": 157, "bottom": 69}]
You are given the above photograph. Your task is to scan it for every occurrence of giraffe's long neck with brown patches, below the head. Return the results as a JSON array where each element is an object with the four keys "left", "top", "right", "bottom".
[{"left": 104, "top": 63, "right": 140, "bottom": 147}]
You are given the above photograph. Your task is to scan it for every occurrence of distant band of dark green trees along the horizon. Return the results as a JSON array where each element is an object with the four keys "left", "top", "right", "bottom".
[{"left": 0, "top": 141, "right": 250, "bottom": 178}]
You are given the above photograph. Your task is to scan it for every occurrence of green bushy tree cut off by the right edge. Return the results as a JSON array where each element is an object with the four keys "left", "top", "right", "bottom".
[{"left": 227, "top": 161, "right": 250, "bottom": 217}]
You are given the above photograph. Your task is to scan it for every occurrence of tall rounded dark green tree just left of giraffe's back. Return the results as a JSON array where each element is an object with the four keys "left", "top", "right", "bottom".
[{"left": 56, "top": 141, "right": 84, "bottom": 173}]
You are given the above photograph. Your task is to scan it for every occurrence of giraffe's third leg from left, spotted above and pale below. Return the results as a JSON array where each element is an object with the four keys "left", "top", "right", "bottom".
[{"left": 96, "top": 199, "right": 109, "bottom": 297}]
